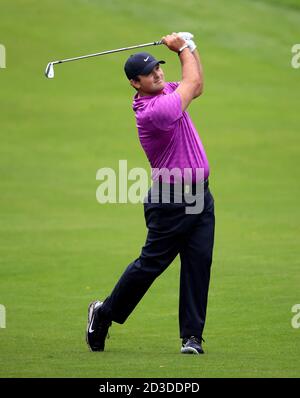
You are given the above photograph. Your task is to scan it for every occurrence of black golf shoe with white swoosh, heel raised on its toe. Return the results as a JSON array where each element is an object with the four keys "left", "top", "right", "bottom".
[{"left": 86, "top": 301, "right": 111, "bottom": 351}]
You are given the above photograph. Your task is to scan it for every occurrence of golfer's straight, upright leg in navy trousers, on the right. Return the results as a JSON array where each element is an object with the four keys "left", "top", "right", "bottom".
[{"left": 179, "top": 190, "right": 215, "bottom": 339}]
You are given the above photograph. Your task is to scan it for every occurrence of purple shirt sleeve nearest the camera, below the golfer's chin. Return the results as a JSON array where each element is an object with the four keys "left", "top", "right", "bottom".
[{"left": 150, "top": 91, "right": 183, "bottom": 131}]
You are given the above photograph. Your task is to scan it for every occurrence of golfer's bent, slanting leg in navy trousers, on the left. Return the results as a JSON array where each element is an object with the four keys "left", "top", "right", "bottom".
[{"left": 102, "top": 204, "right": 185, "bottom": 323}]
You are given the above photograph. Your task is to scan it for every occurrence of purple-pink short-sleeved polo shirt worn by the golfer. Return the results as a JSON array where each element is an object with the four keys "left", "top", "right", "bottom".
[{"left": 133, "top": 82, "right": 209, "bottom": 182}]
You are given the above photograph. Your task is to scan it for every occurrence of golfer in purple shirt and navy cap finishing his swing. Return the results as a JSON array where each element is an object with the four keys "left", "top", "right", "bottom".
[{"left": 86, "top": 32, "right": 215, "bottom": 354}]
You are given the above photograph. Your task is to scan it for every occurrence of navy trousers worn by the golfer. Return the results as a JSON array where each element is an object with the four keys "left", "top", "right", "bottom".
[{"left": 103, "top": 184, "right": 215, "bottom": 338}]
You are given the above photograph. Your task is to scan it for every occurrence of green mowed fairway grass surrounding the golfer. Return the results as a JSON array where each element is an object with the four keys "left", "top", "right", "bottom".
[{"left": 0, "top": 0, "right": 300, "bottom": 378}]
